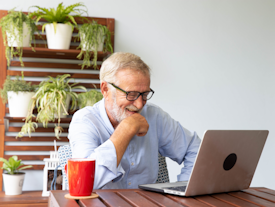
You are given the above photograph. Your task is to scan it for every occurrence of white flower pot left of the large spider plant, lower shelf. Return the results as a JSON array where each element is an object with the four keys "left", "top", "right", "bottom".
[{"left": 8, "top": 91, "right": 35, "bottom": 117}]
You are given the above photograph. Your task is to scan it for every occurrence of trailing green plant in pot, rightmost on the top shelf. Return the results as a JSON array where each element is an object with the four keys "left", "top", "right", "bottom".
[{"left": 77, "top": 21, "right": 113, "bottom": 69}]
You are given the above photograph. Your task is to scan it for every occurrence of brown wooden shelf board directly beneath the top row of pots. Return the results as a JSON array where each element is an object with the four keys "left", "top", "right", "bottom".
[{"left": 20, "top": 47, "right": 110, "bottom": 61}]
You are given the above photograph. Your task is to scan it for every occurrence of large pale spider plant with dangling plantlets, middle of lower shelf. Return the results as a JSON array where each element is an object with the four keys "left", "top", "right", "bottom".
[{"left": 17, "top": 74, "right": 86, "bottom": 139}]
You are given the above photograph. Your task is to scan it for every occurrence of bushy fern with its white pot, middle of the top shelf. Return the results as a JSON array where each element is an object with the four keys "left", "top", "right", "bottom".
[{"left": 30, "top": 3, "right": 87, "bottom": 49}]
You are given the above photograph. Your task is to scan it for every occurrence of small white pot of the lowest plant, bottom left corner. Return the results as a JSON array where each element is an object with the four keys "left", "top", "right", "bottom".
[{"left": 3, "top": 173, "right": 25, "bottom": 195}]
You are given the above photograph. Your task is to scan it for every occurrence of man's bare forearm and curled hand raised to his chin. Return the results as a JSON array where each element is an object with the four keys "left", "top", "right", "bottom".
[{"left": 110, "top": 113, "right": 149, "bottom": 166}]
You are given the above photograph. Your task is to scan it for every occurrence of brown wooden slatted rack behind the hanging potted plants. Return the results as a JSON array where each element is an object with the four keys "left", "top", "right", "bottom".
[{"left": 0, "top": 10, "right": 115, "bottom": 191}]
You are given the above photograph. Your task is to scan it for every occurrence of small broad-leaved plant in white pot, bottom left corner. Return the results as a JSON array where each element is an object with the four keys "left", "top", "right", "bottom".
[{"left": 0, "top": 156, "right": 32, "bottom": 195}]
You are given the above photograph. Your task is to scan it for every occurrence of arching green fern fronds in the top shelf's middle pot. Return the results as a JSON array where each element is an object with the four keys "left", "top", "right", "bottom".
[{"left": 30, "top": 2, "right": 88, "bottom": 32}]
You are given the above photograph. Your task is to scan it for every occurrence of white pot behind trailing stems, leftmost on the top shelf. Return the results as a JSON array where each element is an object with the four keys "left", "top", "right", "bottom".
[{"left": 7, "top": 22, "right": 30, "bottom": 47}]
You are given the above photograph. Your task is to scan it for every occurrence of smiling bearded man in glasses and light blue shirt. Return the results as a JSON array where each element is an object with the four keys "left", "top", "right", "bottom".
[{"left": 69, "top": 53, "right": 200, "bottom": 189}]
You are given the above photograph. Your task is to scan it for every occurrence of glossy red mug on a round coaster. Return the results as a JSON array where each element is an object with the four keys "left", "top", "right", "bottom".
[{"left": 65, "top": 158, "right": 95, "bottom": 196}]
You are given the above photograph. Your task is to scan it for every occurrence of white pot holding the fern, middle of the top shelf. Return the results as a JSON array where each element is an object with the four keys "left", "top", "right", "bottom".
[{"left": 45, "top": 24, "right": 72, "bottom": 50}]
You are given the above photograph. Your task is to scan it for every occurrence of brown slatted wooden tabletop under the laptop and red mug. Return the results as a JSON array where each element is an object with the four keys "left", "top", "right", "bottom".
[{"left": 49, "top": 188, "right": 275, "bottom": 207}]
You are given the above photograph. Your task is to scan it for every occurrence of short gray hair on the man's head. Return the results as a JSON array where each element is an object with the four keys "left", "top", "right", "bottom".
[{"left": 100, "top": 52, "right": 151, "bottom": 84}]
